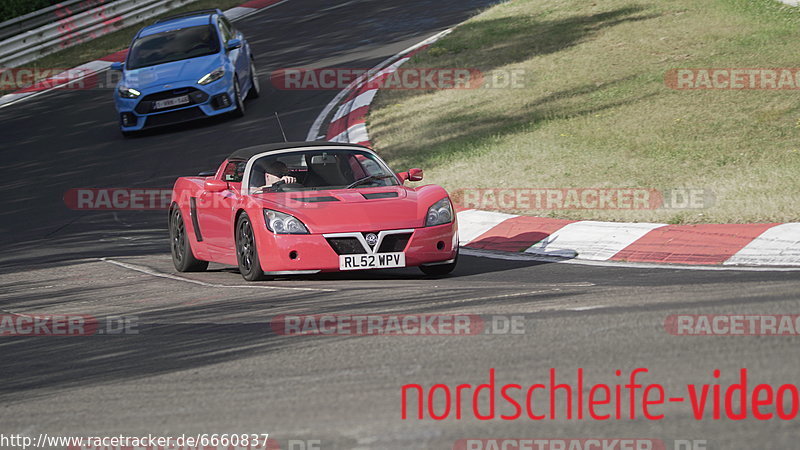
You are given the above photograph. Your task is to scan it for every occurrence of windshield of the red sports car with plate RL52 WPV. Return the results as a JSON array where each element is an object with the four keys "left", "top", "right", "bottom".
[{"left": 250, "top": 149, "right": 398, "bottom": 193}]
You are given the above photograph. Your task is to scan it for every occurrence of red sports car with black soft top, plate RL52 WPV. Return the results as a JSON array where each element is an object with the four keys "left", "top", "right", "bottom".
[{"left": 169, "top": 142, "right": 458, "bottom": 281}]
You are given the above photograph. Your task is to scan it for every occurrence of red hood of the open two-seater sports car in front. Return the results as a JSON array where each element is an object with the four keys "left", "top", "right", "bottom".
[{"left": 253, "top": 186, "right": 431, "bottom": 234}]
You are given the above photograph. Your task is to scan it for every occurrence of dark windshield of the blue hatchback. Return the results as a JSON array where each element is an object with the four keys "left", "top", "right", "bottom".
[{"left": 126, "top": 25, "right": 220, "bottom": 69}]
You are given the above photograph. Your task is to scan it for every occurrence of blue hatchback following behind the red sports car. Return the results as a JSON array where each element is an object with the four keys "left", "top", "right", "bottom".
[{"left": 111, "top": 9, "right": 260, "bottom": 135}]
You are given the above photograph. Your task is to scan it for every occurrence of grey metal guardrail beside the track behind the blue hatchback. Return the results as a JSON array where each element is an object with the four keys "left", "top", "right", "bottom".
[{"left": 0, "top": 0, "right": 194, "bottom": 67}]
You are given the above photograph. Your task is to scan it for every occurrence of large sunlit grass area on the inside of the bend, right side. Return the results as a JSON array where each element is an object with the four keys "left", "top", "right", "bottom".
[{"left": 368, "top": 0, "right": 800, "bottom": 223}]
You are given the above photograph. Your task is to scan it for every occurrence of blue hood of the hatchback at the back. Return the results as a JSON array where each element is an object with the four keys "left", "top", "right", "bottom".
[{"left": 122, "top": 54, "right": 224, "bottom": 90}]
